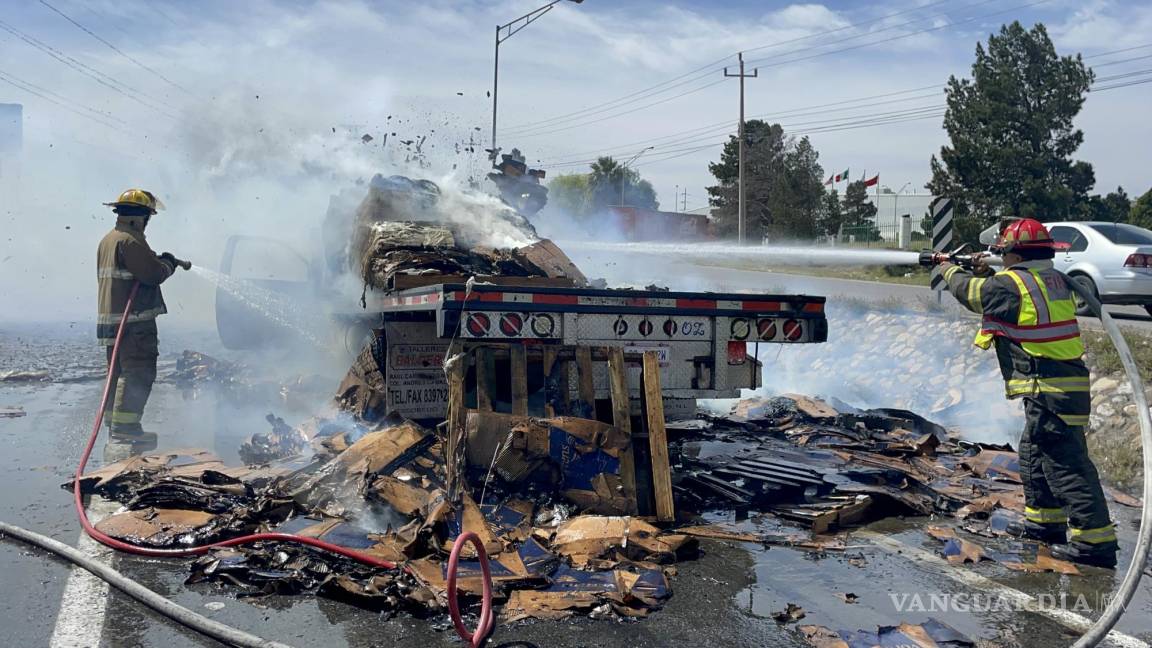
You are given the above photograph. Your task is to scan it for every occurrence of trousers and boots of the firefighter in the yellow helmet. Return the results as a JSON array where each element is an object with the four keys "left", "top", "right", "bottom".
[{"left": 104, "top": 319, "right": 159, "bottom": 460}]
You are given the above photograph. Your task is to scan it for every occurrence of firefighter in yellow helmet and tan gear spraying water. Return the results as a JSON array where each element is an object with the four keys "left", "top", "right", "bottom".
[{"left": 96, "top": 189, "right": 191, "bottom": 464}]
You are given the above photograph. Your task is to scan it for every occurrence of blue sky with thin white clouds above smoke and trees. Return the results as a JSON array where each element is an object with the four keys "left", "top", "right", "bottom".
[{"left": 0, "top": 0, "right": 1152, "bottom": 201}]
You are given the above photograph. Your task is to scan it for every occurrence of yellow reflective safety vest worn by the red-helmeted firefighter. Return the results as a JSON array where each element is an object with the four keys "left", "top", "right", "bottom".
[{"left": 976, "top": 268, "right": 1084, "bottom": 360}]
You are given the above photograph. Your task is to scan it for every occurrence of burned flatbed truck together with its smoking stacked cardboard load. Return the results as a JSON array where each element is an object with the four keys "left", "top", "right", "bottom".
[{"left": 217, "top": 176, "right": 827, "bottom": 421}]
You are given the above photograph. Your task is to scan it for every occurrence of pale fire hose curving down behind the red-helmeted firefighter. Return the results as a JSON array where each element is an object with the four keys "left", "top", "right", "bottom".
[{"left": 1064, "top": 276, "right": 1152, "bottom": 648}]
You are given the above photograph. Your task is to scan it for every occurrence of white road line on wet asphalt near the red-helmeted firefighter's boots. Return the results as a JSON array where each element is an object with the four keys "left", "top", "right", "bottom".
[{"left": 852, "top": 530, "right": 1149, "bottom": 648}]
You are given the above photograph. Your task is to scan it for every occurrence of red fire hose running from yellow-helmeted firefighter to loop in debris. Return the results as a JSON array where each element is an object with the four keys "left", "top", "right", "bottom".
[{"left": 73, "top": 281, "right": 493, "bottom": 648}]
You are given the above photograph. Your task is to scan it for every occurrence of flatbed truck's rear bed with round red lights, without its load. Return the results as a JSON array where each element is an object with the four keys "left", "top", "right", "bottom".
[{"left": 342, "top": 284, "right": 827, "bottom": 420}]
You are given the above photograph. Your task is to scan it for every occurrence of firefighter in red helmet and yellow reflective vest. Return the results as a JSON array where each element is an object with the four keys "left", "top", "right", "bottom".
[{"left": 935, "top": 218, "right": 1117, "bottom": 567}]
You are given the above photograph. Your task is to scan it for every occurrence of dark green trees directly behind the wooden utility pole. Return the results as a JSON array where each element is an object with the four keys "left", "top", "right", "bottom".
[{"left": 707, "top": 120, "right": 824, "bottom": 240}]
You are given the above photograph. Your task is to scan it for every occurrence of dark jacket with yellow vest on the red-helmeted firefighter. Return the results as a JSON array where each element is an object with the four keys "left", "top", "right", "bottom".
[{"left": 939, "top": 262, "right": 1091, "bottom": 410}]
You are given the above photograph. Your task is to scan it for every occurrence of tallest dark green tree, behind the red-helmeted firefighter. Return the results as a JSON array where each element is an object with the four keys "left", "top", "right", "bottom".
[{"left": 927, "top": 22, "right": 1096, "bottom": 241}]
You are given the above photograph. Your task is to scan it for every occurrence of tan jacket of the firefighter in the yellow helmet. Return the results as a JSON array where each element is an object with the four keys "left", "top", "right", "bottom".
[{"left": 96, "top": 217, "right": 175, "bottom": 345}]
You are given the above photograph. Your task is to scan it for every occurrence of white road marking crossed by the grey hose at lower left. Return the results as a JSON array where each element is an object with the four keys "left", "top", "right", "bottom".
[{"left": 48, "top": 497, "right": 119, "bottom": 648}]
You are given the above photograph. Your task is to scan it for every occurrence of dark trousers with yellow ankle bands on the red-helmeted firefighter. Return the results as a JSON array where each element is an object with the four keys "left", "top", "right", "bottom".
[{"left": 1020, "top": 398, "right": 1116, "bottom": 545}]
